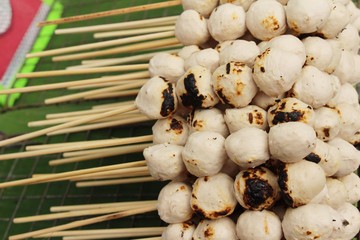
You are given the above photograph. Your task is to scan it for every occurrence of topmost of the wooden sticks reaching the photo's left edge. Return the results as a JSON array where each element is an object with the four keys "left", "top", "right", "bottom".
[{"left": 0, "top": 71, "right": 150, "bottom": 95}]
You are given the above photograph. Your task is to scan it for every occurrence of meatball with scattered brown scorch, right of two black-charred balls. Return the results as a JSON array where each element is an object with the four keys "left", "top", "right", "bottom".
[{"left": 212, "top": 62, "right": 257, "bottom": 107}]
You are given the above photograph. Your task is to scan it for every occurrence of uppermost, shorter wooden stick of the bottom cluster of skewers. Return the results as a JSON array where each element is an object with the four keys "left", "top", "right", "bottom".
[{"left": 50, "top": 200, "right": 157, "bottom": 212}]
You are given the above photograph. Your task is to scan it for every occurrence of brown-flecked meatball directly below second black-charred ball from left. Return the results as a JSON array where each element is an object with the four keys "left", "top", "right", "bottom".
[{"left": 189, "top": 108, "right": 229, "bottom": 137}]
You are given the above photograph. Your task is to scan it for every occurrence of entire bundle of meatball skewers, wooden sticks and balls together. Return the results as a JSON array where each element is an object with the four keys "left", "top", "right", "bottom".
[{"left": 0, "top": 0, "right": 360, "bottom": 240}]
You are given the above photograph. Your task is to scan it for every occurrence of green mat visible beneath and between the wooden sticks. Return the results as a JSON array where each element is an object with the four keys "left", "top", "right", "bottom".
[{"left": 0, "top": 0, "right": 181, "bottom": 239}]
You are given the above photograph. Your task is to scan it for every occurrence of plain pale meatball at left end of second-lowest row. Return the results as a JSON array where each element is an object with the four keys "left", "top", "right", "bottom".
[{"left": 157, "top": 182, "right": 194, "bottom": 223}]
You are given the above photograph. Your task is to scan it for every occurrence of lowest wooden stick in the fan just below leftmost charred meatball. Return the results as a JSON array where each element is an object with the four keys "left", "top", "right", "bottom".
[{"left": 46, "top": 115, "right": 153, "bottom": 136}]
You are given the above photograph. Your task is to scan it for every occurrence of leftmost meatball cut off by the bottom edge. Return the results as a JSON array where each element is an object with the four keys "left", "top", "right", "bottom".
[{"left": 161, "top": 223, "right": 195, "bottom": 240}]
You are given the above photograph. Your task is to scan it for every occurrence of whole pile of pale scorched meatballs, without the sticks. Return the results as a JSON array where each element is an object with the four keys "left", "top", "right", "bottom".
[{"left": 135, "top": 0, "right": 360, "bottom": 240}]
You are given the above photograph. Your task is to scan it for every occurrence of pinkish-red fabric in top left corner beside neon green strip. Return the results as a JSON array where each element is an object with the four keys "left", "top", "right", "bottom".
[{"left": 0, "top": 0, "right": 41, "bottom": 81}]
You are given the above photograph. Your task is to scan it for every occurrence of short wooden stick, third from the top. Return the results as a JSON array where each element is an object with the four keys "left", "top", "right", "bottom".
[{"left": 94, "top": 24, "right": 175, "bottom": 39}]
